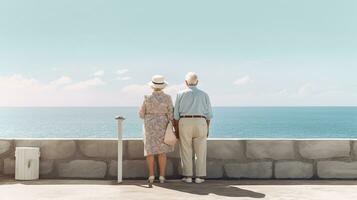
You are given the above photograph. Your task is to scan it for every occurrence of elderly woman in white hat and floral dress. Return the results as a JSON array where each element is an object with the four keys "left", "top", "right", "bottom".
[{"left": 139, "top": 75, "right": 173, "bottom": 183}]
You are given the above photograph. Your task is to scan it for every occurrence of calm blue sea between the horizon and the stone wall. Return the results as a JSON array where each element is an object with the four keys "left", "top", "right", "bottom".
[{"left": 0, "top": 107, "right": 357, "bottom": 138}]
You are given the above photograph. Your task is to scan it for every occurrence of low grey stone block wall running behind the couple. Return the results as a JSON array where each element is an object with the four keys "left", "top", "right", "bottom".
[{"left": 0, "top": 139, "right": 357, "bottom": 179}]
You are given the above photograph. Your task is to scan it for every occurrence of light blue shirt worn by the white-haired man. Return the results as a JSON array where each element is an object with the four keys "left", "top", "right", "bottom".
[{"left": 174, "top": 86, "right": 213, "bottom": 120}]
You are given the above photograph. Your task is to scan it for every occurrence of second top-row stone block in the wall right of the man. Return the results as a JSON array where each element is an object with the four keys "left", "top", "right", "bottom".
[{"left": 247, "top": 140, "right": 295, "bottom": 160}]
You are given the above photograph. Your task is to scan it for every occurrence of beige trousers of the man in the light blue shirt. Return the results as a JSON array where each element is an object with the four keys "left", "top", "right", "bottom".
[{"left": 179, "top": 118, "right": 208, "bottom": 177}]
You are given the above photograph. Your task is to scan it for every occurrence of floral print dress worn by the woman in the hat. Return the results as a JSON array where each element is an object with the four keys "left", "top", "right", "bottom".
[{"left": 139, "top": 91, "right": 174, "bottom": 156}]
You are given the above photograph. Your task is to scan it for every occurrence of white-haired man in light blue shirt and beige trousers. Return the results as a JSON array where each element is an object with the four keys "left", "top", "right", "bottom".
[{"left": 174, "top": 72, "right": 212, "bottom": 183}]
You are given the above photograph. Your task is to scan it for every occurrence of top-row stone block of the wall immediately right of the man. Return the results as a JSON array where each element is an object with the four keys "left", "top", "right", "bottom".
[{"left": 207, "top": 140, "right": 245, "bottom": 160}]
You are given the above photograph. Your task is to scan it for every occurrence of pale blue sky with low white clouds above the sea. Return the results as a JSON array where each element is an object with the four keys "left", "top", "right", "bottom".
[{"left": 0, "top": 0, "right": 357, "bottom": 106}]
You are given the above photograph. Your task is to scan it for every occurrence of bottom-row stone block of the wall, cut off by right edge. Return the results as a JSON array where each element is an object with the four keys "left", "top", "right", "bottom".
[{"left": 317, "top": 161, "right": 357, "bottom": 179}]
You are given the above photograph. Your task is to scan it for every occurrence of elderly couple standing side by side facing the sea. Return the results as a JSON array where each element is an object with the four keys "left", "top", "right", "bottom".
[{"left": 139, "top": 72, "right": 212, "bottom": 184}]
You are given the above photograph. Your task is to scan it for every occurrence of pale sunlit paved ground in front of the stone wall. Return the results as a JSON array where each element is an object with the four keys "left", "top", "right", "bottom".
[{"left": 0, "top": 178, "right": 357, "bottom": 200}]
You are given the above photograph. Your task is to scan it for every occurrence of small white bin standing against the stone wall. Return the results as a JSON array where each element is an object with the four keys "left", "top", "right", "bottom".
[{"left": 15, "top": 147, "right": 40, "bottom": 180}]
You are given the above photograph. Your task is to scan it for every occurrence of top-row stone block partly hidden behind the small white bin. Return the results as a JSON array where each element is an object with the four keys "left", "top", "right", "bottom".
[{"left": 15, "top": 140, "right": 76, "bottom": 160}]
